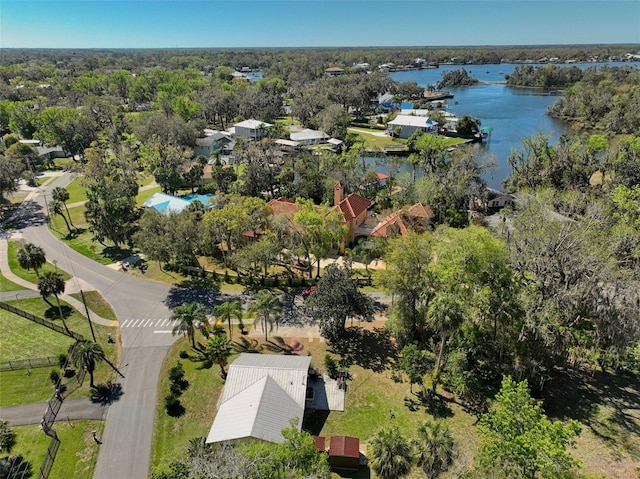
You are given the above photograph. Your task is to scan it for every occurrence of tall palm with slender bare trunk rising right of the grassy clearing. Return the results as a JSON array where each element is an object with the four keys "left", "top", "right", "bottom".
[{"left": 427, "top": 293, "right": 464, "bottom": 392}]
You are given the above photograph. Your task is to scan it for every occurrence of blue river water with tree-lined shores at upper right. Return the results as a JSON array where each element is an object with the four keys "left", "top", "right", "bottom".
[{"left": 391, "top": 62, "right": 640, "bottom": 189}]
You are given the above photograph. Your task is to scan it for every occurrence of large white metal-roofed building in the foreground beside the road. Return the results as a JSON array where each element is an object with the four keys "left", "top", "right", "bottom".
[{"left": 206, "top": 353, "right": 311, "bottom": 443}]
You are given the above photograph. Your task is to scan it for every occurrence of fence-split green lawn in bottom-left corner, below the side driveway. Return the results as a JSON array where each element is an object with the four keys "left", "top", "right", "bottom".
[{"left": 12, "top": 420, "right": 104, "bottom": 479}]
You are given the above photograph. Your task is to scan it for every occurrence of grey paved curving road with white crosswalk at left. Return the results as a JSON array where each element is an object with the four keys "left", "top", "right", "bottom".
[{"left": 16, "top": 174, "right": 176, "bottom": 479}]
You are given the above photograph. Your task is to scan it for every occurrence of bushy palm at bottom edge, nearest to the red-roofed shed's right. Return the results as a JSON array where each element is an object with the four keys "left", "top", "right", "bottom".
[{"left": 368, "top": 428, "right": 413, "bottom": 479}]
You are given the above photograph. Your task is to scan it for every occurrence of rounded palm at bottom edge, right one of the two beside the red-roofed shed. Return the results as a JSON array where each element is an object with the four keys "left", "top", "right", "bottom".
[{"left": 414, "top": 419, "right": 455, "bottom": 479}]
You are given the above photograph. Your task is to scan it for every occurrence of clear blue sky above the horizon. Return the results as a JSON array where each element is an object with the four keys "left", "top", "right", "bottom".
[{"left": 0, "top": 0, "right": 640, "bottom": 48}]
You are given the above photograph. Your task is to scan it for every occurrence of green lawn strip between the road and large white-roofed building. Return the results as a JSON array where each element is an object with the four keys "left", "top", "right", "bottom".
[{"left": 151, "top": 337, "right": 225, "bottom": 471}]
